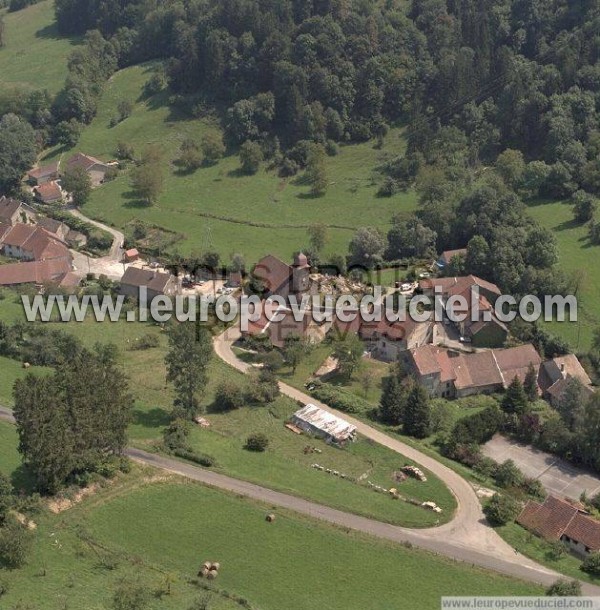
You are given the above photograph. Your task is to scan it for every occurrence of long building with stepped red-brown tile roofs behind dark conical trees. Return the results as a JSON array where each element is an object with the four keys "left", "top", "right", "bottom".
[{"left": 403, "top": 344, "right": 541, "bottom": 398}]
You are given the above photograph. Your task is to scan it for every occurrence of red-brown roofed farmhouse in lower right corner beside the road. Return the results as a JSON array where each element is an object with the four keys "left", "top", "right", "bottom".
[{"left": 517, "top": 496, "right": 600, "bottom": 557}]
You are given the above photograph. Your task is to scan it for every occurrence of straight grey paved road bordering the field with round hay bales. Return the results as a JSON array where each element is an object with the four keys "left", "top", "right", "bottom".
[{"left": 0, "top": 400, "right": 600, "bottom": 596}]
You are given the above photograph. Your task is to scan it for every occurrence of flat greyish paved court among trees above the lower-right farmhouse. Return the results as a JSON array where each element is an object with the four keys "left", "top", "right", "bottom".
[{"left": 482, "top": 435, "right": 600, "bottom": 500}]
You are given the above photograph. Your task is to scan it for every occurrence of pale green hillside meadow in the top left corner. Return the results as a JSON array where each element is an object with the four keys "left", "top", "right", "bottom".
[{"left": 0, "top": 0, "right": 78, "bottom": 94}]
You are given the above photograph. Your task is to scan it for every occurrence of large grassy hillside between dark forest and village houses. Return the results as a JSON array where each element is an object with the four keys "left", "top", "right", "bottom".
[{"left": 43, "top": 65, "right": 415, "bottom": 261}]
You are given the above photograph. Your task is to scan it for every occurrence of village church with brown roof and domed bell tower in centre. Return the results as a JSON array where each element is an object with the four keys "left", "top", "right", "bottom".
[{"left": 253, "top": 253, "right": 310, "bottom": 298}]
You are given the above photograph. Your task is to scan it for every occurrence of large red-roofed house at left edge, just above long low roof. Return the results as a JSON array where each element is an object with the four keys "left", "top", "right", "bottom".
[{"left": 0, "top": 224, "right": 71, "bottom": 261}]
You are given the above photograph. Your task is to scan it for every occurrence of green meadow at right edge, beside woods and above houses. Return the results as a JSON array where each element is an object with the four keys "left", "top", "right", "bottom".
[{"left": 529, "top": 201, "right": 600, "bottom": 351}]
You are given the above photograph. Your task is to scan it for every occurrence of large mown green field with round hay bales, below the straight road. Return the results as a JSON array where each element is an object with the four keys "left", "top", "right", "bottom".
[{"left": 0, "top": 423, "right": 541, "bottom": 610}]
